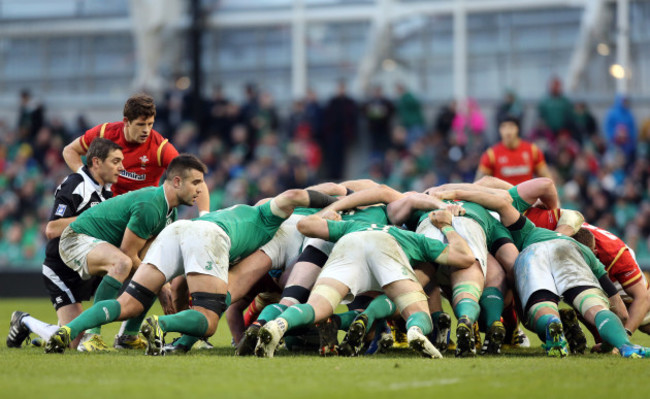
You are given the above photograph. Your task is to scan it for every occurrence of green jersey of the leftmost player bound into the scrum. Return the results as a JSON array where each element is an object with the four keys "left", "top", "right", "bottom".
[{"left": 194, "top": 201, "right": 285, "bottom": 264}]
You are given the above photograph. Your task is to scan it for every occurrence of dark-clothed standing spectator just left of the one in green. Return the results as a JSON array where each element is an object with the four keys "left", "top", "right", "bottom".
[{"left": 363, "top": 86, "right": 395, "bottom": 153}]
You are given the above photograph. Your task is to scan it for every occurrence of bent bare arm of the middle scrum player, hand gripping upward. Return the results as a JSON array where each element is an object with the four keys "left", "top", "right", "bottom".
[{"left": 429, "top": 210, "right": 474, "bottom": 269}]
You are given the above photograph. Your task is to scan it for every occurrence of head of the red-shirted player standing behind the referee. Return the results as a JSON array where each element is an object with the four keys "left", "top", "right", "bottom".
[{"left": 123, "top": 93, "right": 156, "bottom": 143}]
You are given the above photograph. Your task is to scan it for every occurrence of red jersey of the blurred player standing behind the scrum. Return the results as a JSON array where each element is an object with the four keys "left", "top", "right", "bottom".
[{"left": 479, "top": 140, "right": 546, "bottom": 185}]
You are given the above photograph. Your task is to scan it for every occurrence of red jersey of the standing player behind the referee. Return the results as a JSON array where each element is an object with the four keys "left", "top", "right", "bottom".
[{"left": 79, "top": 122, "right": 178, "bottom": 195}]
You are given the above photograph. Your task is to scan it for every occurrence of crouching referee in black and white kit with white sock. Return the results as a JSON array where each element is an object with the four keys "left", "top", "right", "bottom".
[{"left": 7, "top": 138, "right": 124, "bottom": 348}]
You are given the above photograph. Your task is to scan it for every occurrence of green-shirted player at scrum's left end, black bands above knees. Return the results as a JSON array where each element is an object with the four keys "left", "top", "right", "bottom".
[{"left": 46, "top": 189, "right": 335, "bottom": 355}]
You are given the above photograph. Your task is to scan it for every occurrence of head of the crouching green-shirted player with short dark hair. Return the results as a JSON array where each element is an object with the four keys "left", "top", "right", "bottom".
[{"left": 165, "top": 154, "right": 208, "bottom": 205}]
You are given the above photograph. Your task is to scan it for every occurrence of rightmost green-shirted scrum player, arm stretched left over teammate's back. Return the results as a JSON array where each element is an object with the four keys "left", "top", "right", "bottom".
[{"left": 437, "top": 190, "right": 650, "bottom": 358}]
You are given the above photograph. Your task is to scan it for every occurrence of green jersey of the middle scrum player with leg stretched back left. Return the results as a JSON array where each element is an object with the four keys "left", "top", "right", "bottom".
[{"left": 327, "top": 220, "right": 447, "bottom": 264}]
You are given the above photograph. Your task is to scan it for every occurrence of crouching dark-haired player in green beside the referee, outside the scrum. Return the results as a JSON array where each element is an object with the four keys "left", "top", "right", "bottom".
[{"left": 46, "top": 154, "right": 206, "bottom": 350}]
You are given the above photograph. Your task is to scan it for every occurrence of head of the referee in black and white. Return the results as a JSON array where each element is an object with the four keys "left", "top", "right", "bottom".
[{"left": 86, "top": 138, "right": 124, "bottom": 184}]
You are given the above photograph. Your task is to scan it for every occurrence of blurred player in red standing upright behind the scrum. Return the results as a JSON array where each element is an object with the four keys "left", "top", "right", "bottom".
[{"left": 476, "top": 118, "right": 551, "bottom": 184}]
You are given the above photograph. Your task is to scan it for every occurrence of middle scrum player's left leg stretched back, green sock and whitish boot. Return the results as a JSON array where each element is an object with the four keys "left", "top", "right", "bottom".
[{"left": 255, "top": 278, "right": 350, "bottom": 357}]
